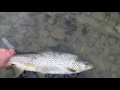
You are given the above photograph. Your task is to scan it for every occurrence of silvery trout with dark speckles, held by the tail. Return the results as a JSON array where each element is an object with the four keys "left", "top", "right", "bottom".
[{"left": 9, "top": 51, "right": 93, "bottom": 77}]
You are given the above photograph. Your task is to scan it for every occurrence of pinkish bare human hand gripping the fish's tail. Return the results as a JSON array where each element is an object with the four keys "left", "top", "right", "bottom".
[{"left": 0, "top": 48, "right": 15, "bottom": 69}]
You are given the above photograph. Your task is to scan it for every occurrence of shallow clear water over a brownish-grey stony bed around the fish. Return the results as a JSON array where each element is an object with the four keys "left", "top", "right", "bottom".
[{"left": 0, "top": 12, "right": 120, "bottom": 78}]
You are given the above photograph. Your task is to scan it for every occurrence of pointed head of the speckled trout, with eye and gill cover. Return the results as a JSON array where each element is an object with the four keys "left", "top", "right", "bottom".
[{"left": 69, "top": 61, "right": 93, "bottom": 73}]
